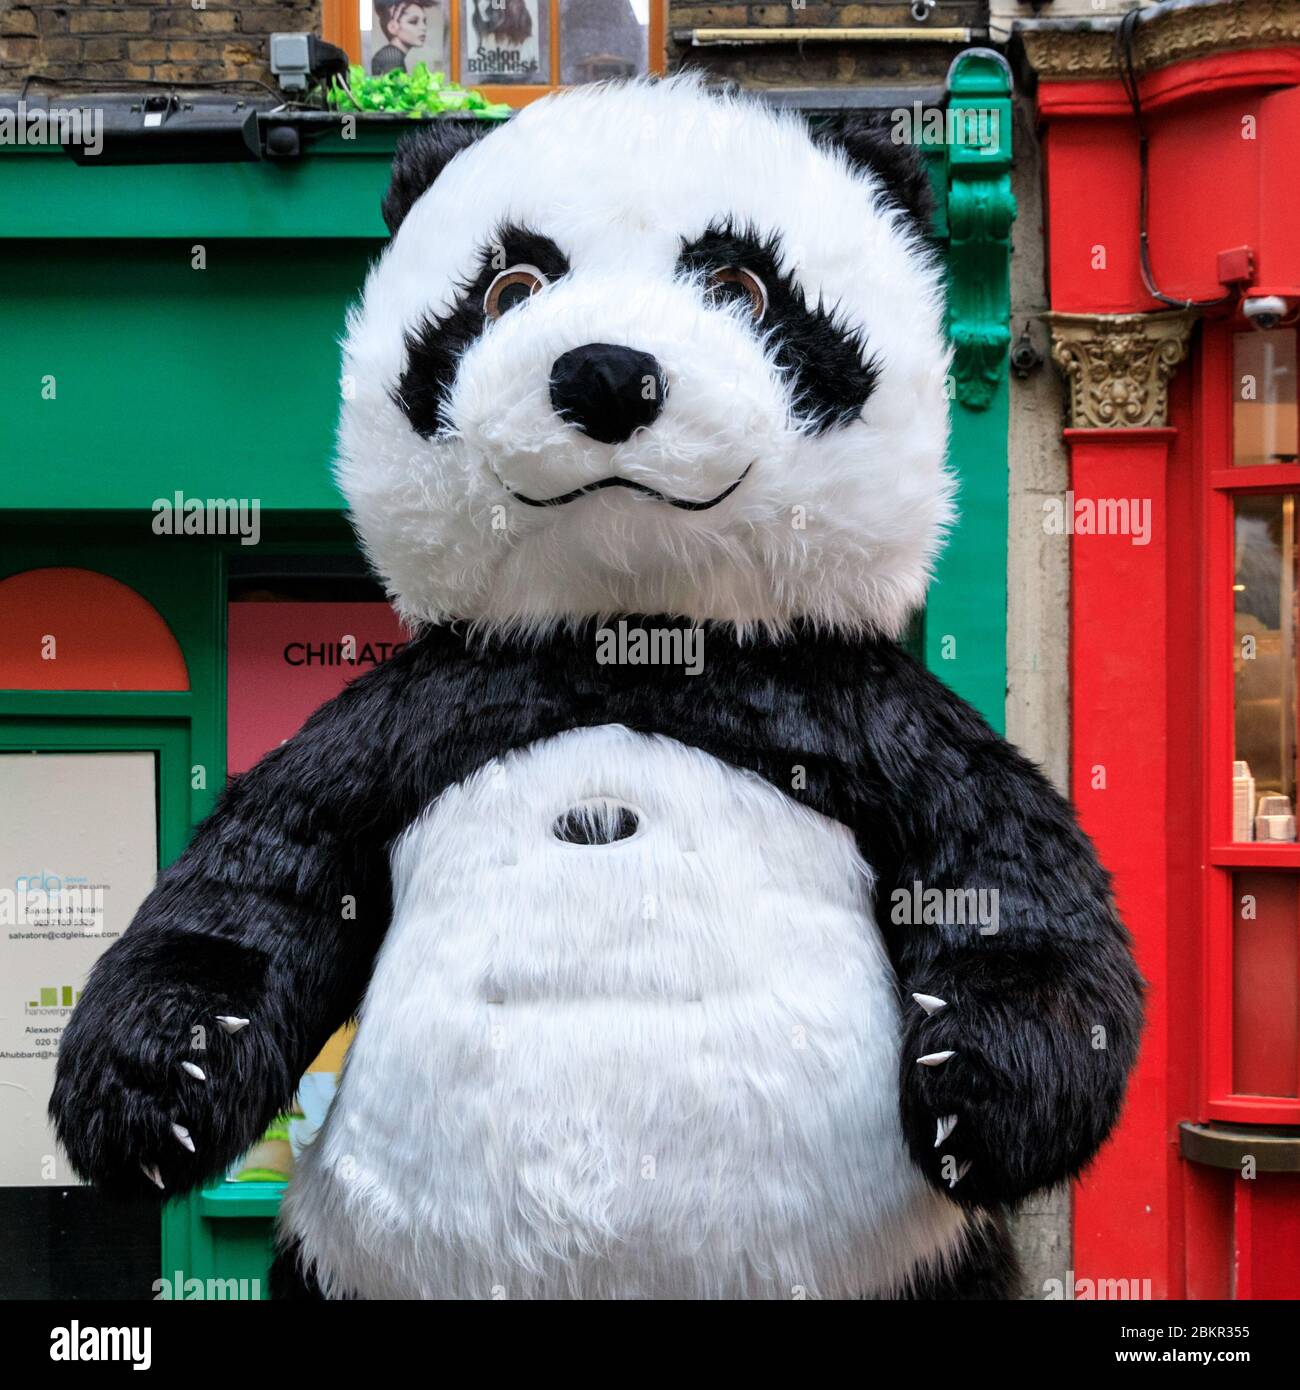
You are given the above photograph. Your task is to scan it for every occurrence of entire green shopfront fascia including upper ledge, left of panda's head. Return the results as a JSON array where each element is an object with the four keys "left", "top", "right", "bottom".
[{"left": 0, "top": 121, "right": 397, "bottom": 512}]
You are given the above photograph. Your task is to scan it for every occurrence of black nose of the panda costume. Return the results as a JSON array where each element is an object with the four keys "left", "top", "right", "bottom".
[{"left": 551, "top": 343, "right": 667, "bottom": 443}]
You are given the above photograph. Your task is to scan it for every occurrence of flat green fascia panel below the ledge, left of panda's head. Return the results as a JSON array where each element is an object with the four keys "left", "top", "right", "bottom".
[{"left": 0, "top": 239, "right": 378, "bottom": 513}]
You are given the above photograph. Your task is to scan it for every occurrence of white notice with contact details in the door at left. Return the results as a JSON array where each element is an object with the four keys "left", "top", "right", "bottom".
[{"left": 0, "top": 752, "right": 159, "bottom": 1187}]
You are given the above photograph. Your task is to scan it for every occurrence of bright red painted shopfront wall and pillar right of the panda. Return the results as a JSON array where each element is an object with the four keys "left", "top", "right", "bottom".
[{"left": 1037, "top": 47, "right": 1300, "bottom": 1298}]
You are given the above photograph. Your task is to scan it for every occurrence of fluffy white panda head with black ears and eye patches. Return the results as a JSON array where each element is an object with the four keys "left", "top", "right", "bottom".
[{"left": 338, "top": 78, "right": 952, "bottom": 635}]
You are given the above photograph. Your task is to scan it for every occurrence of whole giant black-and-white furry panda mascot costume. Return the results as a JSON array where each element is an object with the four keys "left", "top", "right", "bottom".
[{"left": 51, "top": 78, "right": 1141, "bottom": 1298}]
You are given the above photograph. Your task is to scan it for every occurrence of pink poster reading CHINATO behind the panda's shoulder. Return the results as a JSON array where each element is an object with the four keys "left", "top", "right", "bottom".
[{"left": 227, "top": 603, "right": 407, "bottom": 777}]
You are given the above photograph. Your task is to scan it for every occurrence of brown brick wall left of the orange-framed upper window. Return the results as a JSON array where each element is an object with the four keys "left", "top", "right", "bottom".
[{"left": 0, "top": 0, "right": 321, "bottom": 88}]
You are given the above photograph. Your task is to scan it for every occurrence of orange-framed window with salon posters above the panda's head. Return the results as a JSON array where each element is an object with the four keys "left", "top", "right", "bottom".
[{"left": 324, "top": 0, "right": 667, "bottom": 106}]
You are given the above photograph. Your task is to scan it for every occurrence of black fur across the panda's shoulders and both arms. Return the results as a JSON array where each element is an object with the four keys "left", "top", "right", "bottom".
[{"left": 50, "top": 619, "right": 1141, "bottom": 1251}]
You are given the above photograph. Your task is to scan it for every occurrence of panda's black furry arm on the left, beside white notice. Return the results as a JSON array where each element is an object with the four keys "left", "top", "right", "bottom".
[{"left": 50, "top": 649, "right": 439, "bottom": 1195}]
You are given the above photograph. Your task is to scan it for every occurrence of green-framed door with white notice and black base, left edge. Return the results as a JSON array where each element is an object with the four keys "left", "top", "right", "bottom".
[{"left": 0, "top": 750, "right": 173, "bottom": 1298}]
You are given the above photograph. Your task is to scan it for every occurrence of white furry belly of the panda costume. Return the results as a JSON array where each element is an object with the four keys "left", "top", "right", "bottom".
[{"left": 282, "top": 726, "right": 965, "bottom": 1298}]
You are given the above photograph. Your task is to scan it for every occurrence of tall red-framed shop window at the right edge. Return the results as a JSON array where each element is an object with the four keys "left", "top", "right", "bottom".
[{"left": 1201, "top": 325, "right": 1300, "bottom": 1125}]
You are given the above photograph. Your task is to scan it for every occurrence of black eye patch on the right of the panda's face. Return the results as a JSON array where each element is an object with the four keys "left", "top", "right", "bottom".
[{"left": 677, "top": 218, "right": 880, "bottom": 434}]
